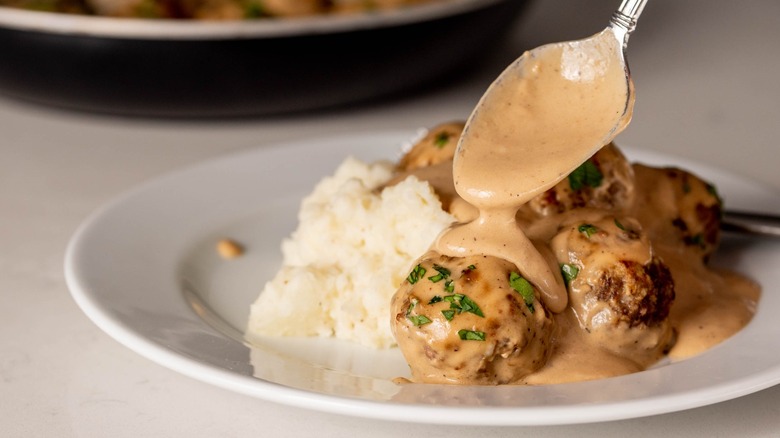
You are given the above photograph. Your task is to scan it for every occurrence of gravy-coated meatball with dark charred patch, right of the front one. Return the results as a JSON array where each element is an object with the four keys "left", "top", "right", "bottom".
[{"left": 552, "top": 209, "right": 675, "bottom": 363}]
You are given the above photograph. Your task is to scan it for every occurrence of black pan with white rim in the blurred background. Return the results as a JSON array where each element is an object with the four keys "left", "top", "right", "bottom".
[{"left": 0, "top": 0, "right": 526, "bottom": 117}]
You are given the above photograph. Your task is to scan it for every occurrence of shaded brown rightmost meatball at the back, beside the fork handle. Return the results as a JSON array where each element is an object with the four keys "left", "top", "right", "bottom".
[{"left": 634, "top": 164, "right": 723, "bottom": 261}]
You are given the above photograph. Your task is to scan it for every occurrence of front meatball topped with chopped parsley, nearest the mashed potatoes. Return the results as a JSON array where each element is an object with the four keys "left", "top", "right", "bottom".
[{"left": 391, "top": 253, "right": 553, "bottom": 385}]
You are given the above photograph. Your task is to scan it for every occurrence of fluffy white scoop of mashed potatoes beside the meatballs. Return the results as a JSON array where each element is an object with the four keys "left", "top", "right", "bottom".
[{"left": 247, "top": 158, "right": 454, "bottom": 348}]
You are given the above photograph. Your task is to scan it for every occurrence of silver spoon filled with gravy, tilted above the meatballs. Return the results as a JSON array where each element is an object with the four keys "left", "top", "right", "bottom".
[{"left": 453, "top": 0, "right": 647, "bottom": 208}]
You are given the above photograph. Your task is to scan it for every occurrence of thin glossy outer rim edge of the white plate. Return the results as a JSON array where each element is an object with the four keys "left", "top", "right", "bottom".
[{"left": 64, "top": 130, "right": 780, "bottom": 426}]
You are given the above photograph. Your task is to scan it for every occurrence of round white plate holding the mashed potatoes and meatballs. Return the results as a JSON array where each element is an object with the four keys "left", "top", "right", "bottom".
[{"left": 65, "top": 132, "right": 780, "bottom": 425}]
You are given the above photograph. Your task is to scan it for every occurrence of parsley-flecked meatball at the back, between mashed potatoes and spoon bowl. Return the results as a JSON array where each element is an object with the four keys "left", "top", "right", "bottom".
[{"left": 398, "top": 122, "right": 465, "bottom": 171}]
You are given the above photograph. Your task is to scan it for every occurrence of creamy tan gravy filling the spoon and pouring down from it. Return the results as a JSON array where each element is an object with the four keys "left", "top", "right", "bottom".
[{"left": 435, "top": 30, "right": 633, "bottom": 312}]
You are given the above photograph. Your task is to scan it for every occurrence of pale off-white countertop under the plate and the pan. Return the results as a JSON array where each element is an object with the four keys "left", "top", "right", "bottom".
[{"left": 0, "top": 0, "right": 780, "bottom": 438}]
